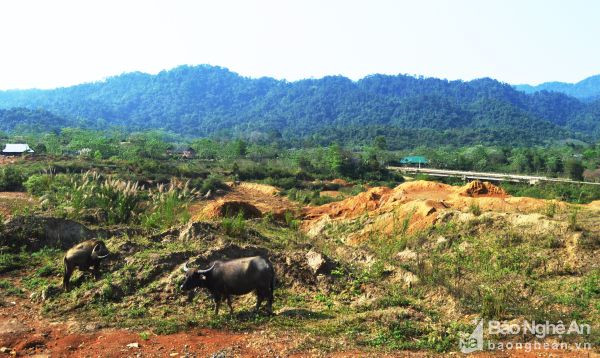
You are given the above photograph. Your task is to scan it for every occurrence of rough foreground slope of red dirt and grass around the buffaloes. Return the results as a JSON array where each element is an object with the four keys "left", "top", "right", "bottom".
[{"left": 0, "top": 181, "right": 600, "bottom": 357}]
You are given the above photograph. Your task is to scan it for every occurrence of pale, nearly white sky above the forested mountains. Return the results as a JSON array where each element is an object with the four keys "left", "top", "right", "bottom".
[{"left": 0, "top": 0, "right": 600, "bottom": 89}]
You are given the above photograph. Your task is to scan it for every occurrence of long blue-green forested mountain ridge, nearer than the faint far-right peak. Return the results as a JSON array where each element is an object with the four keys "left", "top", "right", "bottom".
[{"left": 0, "top": 65, "right": 600, "bottom": 145}]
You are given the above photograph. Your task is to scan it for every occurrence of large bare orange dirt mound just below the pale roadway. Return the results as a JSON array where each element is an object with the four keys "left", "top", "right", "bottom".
[{"left": 302, "top": 181, "right": 567, "bottom": 243}]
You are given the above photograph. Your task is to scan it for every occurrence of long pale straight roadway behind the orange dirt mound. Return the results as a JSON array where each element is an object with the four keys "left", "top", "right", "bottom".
[{"left": 388, "top": 166, "right": 600, "bottom": 185}]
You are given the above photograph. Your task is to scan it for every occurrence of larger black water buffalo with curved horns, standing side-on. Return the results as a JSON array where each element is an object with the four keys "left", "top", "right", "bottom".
[{"left": 181, "top": 256, "right": 275, "bottom": 314}]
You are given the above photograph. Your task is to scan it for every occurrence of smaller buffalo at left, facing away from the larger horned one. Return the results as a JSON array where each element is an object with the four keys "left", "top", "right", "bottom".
[{"left": 63, "top": 240, "right": 109, "bottom": 291}]
